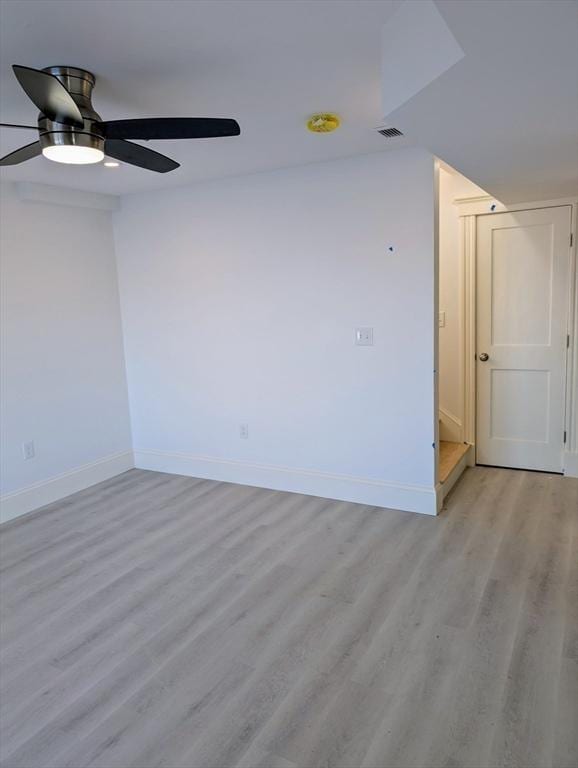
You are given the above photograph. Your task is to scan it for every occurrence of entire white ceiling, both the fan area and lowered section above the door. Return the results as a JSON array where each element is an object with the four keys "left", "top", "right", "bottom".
[{"left": 0, "top": 0, "right": 578, "bottom": 201}]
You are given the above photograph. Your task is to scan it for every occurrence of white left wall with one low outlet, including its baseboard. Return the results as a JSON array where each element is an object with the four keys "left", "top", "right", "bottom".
[{"left": 0, "top": 185, "right": 132, "bottom": 519}]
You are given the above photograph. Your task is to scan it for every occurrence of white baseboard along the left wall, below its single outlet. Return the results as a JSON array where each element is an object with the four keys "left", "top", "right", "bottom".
[{"left": 0, "top": 451, "right": 134, "bottom": 523}]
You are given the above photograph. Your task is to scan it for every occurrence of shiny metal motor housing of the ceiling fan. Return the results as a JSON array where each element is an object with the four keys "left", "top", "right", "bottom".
[{"left": 38, "top": 67, "right": 104, "bottom": 152}]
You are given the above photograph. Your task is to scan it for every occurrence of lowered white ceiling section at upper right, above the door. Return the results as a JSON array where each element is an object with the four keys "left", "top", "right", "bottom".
[{"left": 384, "top": 0, "right": 578, "bottom": 202}]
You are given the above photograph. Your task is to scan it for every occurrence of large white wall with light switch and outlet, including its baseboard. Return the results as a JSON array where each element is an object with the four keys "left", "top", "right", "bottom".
[{"left": 115, "top": 149, "right": 437, "bottom": 512}]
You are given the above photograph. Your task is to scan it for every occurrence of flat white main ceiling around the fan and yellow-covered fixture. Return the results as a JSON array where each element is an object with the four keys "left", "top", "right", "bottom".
[{"left": 0, "top": 0, "right": 405, "bottom": 193}]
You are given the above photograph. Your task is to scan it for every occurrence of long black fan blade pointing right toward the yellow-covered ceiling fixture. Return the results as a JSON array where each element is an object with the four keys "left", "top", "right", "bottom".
[{"left": 100, "top": 117, "right": 241, "bottom": 141}]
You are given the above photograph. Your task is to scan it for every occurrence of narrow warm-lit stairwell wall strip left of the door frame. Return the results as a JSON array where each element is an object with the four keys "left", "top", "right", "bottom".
[{"left": 438, "top": 166, "right": 486, "bottom": 442}]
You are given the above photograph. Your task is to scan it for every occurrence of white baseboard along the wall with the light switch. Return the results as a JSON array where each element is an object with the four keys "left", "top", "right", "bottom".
[{"left": 134, "top": 449, "right": 437, "bottom": 515}]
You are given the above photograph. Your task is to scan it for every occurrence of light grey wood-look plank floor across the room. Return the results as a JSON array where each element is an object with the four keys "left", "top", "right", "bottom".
[{"left": 0, "top": 467, "right": 578, "bottom": 768}]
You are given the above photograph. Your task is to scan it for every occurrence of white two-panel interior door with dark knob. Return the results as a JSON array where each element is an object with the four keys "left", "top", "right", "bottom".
[{"left": 476, "top": 206, "right": 571, "bottom": 472}]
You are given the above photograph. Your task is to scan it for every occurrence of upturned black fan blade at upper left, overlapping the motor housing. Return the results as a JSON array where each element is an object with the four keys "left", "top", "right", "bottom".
[{"left": 12, "top": 64, "right": 84, "bottom": 128}]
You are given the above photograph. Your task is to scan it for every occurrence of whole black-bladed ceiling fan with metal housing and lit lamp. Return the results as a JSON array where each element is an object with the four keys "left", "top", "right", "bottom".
[{"left": 0, "top": 65, "right": 241, "bottom": 173}]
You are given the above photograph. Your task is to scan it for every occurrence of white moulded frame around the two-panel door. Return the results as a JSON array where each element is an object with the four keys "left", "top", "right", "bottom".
[{"left": 452, "top": 196, "right": 578, "bottom": 477}]
